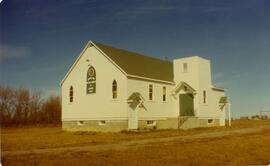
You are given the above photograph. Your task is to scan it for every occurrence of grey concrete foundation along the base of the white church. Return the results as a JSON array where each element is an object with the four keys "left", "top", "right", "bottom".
[{"left": 62, "top": 117, "right": 220, "bottom": 132}]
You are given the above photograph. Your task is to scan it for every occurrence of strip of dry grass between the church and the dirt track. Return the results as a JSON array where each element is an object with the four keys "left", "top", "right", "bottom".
[{"left": 1, "top": 120, "right": 270, "bottom": 150}]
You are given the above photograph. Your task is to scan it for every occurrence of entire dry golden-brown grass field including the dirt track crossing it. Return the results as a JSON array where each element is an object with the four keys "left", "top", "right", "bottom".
[{"left": 1, "top": 120, "right": 270, "bottom": 165}]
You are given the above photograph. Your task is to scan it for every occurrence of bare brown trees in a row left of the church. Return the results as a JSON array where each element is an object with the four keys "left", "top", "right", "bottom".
[{"left": 0, "top": 86, "right": 61, "bottom": 126}]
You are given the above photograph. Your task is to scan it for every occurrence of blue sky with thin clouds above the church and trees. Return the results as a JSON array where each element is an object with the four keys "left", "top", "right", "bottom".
[{"left": 0, "top": 0, "right": 270, "bottom": 116}]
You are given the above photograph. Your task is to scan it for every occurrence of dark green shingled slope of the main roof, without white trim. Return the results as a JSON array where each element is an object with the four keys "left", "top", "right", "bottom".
[{"left": 94, "top": 42, "right": 173, "bottom": 82}]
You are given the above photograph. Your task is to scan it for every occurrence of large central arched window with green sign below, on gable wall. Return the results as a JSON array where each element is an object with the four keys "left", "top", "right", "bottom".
[{"left": 86, "top": 66, "right": 96, "bottom": 94}]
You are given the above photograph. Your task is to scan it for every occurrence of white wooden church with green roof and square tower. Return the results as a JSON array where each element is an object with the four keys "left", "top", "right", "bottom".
[{"left": 61, "top": 41, "right": 229, "bottom": 131}]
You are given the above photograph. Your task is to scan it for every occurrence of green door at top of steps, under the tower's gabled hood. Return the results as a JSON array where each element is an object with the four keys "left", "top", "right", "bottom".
[{"left": 179, "top": 94, "right": 194, "bottom": 116}]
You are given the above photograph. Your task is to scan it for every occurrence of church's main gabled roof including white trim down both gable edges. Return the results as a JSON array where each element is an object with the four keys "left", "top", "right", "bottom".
[{"left": 60, "top": 41, "right": 174, "bottom": 86}]
